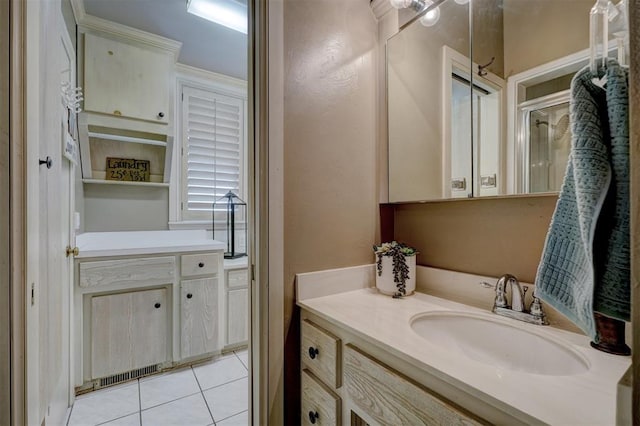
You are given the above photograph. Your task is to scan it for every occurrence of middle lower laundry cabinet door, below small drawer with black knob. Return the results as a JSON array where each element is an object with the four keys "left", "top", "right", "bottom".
[{"left": 180, "top": 278, "right": 219, "bottom": 358}]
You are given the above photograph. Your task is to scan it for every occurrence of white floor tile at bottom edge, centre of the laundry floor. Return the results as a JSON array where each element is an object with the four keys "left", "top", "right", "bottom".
[{"left": 142, "top": 393, "right": 212, "bottom": 426}]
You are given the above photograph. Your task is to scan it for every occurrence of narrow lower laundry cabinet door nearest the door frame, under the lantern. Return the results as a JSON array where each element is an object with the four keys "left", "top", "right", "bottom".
[{"left": 225, "top": 268, "right": 249, "bottom": 347}]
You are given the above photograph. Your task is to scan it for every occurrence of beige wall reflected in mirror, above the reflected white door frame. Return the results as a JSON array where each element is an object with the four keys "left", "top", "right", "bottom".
[{"left": 503, "top": 0, "right": 595, "bottom": 78}]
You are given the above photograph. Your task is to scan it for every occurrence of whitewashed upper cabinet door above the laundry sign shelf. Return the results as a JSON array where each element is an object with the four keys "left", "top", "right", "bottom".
[{"left": 84, "top": 34, "right": 173, "bottom": 123}]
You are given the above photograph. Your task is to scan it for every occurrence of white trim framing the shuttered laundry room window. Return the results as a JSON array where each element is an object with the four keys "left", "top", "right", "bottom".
[{"left": 168, "top": 64, "right": 248, "bottom": 229}]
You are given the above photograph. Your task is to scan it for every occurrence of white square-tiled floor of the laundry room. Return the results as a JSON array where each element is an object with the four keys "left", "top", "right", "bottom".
[{"left": 67, "top": 350, "right": 249, "bottom": 426}]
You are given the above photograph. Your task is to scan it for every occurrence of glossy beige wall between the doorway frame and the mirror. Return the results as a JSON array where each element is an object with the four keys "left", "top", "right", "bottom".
[{"left": 284, "top": 0, "right": 378, "bottom": 424}]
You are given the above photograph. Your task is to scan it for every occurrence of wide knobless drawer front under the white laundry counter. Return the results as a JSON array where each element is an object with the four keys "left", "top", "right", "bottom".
[{"left": 78, "top": 256, "right": 176, "bottom": 288}]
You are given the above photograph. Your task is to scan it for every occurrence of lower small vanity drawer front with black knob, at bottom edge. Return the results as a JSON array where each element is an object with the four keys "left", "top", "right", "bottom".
[{"left": 301, "top": 369, "right": 342, "bottom": 426}]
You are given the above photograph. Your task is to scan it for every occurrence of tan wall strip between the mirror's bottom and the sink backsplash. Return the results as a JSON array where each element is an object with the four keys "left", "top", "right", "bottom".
[{"left": 394, "top": 196, "right": 557, "bottom": 282}]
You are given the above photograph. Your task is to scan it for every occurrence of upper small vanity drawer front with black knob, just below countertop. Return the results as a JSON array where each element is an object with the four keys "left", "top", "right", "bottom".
[{"left": 300, "top": 320, "right": 342, "bottom": 389}]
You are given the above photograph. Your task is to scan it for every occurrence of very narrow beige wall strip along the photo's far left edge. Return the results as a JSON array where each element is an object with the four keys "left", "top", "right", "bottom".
[{"left": 0, "top": 1, "right": 11, "bottom": 424}]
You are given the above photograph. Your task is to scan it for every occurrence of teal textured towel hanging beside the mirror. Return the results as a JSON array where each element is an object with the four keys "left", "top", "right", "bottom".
[{"left": 535, "top": 60, "right": 630, "bottom": 342}]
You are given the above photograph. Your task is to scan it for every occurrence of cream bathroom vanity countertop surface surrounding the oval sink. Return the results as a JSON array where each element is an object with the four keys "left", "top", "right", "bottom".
[{"left": 298, "top": 288, "right": 631, "bottom": 425}]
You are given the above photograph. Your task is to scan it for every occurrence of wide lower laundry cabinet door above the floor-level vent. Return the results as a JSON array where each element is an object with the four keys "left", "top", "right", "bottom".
[{"left": 91, "top": 288, "right": 169, "bottom": 378}]
